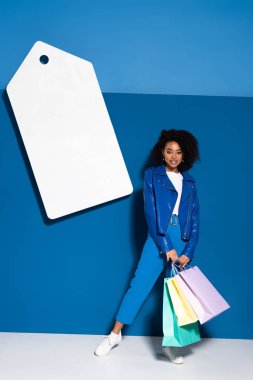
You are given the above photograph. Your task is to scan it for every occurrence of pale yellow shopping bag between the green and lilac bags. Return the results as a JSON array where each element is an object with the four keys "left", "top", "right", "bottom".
[{"left": 167, "top": 277, "right": 198, "bottom": 326}]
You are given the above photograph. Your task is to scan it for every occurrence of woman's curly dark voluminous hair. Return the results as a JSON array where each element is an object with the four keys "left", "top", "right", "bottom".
[{"left": 151, "top": 129, "right": 200, "bottom": 172}]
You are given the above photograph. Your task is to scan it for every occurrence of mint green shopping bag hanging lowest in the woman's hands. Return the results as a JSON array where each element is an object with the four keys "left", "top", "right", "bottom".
[{"left": 162, "top": 277, "right": 201, "bottom": 347}]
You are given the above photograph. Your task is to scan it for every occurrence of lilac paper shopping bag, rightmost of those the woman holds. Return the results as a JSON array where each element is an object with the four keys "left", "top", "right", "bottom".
[{"left": 175, "top": 266, "right": 230, "bottom": 324}]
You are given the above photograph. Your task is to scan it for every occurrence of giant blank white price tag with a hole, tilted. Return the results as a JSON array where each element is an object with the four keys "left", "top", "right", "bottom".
[{"left": 7, "top": 41, "right": 133, "bottom": 219}]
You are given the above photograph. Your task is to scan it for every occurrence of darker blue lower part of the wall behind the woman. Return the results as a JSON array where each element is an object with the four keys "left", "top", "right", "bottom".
[{"left": 0, "top": 94, "right": 253, "bottom": 338}]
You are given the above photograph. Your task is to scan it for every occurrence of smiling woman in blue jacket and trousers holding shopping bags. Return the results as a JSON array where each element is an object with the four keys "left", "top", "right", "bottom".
[{"left": 95, "top": 129, "right": 199, "bottom": 364}]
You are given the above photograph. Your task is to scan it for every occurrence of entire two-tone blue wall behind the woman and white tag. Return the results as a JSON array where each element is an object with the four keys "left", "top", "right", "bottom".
[{"left": 0, "top": 0, "right": 253, "bottom": 338}]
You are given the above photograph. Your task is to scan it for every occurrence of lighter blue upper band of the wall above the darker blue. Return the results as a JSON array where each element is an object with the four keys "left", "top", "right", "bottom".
[{"left": 0, "top": 0, "right": 253, "bottom": 96}]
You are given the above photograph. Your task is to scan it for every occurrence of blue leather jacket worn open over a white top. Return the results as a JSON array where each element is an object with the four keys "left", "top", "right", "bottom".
[{"left": 143, "top": 165, "right": 199, "bottom": 260}]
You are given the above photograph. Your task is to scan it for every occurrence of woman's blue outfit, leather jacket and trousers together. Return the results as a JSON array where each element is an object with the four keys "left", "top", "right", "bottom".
[{"left": 116, "top": 165, "right": 199, "bottom": 324}]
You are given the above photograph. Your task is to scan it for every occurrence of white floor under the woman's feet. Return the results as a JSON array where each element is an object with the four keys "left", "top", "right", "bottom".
[{"left": 0, "top": 333, "right": 253, "bottom": 380}]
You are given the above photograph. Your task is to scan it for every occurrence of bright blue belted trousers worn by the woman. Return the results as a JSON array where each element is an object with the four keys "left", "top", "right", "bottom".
[{"left": 116, "top": 215, "right": 186, "bottom": 325}]
